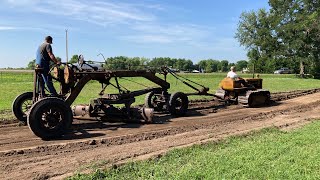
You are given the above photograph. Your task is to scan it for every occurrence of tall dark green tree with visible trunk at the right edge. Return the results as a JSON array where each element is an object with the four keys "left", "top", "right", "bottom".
[{"left": 270, "top": 0, "right": 320, "bottom": 74}]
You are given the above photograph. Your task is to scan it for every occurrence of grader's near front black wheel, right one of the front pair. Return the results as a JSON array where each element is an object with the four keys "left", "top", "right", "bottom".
[{"left": 169, "top": 92, "right": 189, "bottom": 116}]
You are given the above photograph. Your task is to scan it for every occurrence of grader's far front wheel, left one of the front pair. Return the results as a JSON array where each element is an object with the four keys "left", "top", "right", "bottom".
[{"left": 144, "top": 91, "right": 165, "bottom": 111}]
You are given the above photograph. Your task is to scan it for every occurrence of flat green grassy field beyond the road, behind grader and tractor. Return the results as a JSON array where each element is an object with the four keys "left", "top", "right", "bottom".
[{"left": 0, "top": 72, "right": 320, "bottom": 119}]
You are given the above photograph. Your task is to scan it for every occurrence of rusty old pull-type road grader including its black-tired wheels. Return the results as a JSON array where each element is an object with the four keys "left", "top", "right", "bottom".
[{"left": 13, "top": 56, "right": 220, "bottom": 140}]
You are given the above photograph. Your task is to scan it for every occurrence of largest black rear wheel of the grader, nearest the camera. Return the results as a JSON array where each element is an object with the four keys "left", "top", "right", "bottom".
[{"left": 27, "top": 97, "right": 73, "bottom": 140}]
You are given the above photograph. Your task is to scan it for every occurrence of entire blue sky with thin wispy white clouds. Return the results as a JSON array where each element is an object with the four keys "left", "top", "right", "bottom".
[{"left": 0, "top": 0, "right": 268, "bottom": 68}]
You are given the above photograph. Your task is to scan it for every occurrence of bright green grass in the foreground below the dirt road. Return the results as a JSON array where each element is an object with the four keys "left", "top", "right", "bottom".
[{"left": 70, "top": 121, "right": 320, "bottom": 179}]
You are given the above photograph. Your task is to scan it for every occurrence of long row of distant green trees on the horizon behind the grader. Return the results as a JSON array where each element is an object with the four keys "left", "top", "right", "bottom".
[{"left": 27, "top": 55, "right": 248, "bottom": 73}]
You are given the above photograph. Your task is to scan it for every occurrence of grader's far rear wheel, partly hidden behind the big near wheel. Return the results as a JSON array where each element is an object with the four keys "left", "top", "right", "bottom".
[{"left": 12, "top": 92, "right": 33, "bottom": 125}]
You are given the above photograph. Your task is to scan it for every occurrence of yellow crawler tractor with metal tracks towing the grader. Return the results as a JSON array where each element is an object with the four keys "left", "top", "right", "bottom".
[{"left": 215, "top": 78, "right": 270, "bottom": 107}]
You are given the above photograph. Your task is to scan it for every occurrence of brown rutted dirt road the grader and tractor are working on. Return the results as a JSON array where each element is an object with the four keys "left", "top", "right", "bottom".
[{"left": 0, "top": 90, "right": 320, "bottom": 179}]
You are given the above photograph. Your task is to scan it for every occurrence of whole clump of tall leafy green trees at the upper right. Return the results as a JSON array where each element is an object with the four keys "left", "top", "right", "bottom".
[{"left": 236, "top": 0, "right": 320, "bottom": 75}]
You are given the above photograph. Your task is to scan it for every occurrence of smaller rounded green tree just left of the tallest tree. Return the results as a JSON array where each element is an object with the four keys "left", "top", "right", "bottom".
[{"left": 236, "top": 9, "right": 280, "bottom": 72}]
